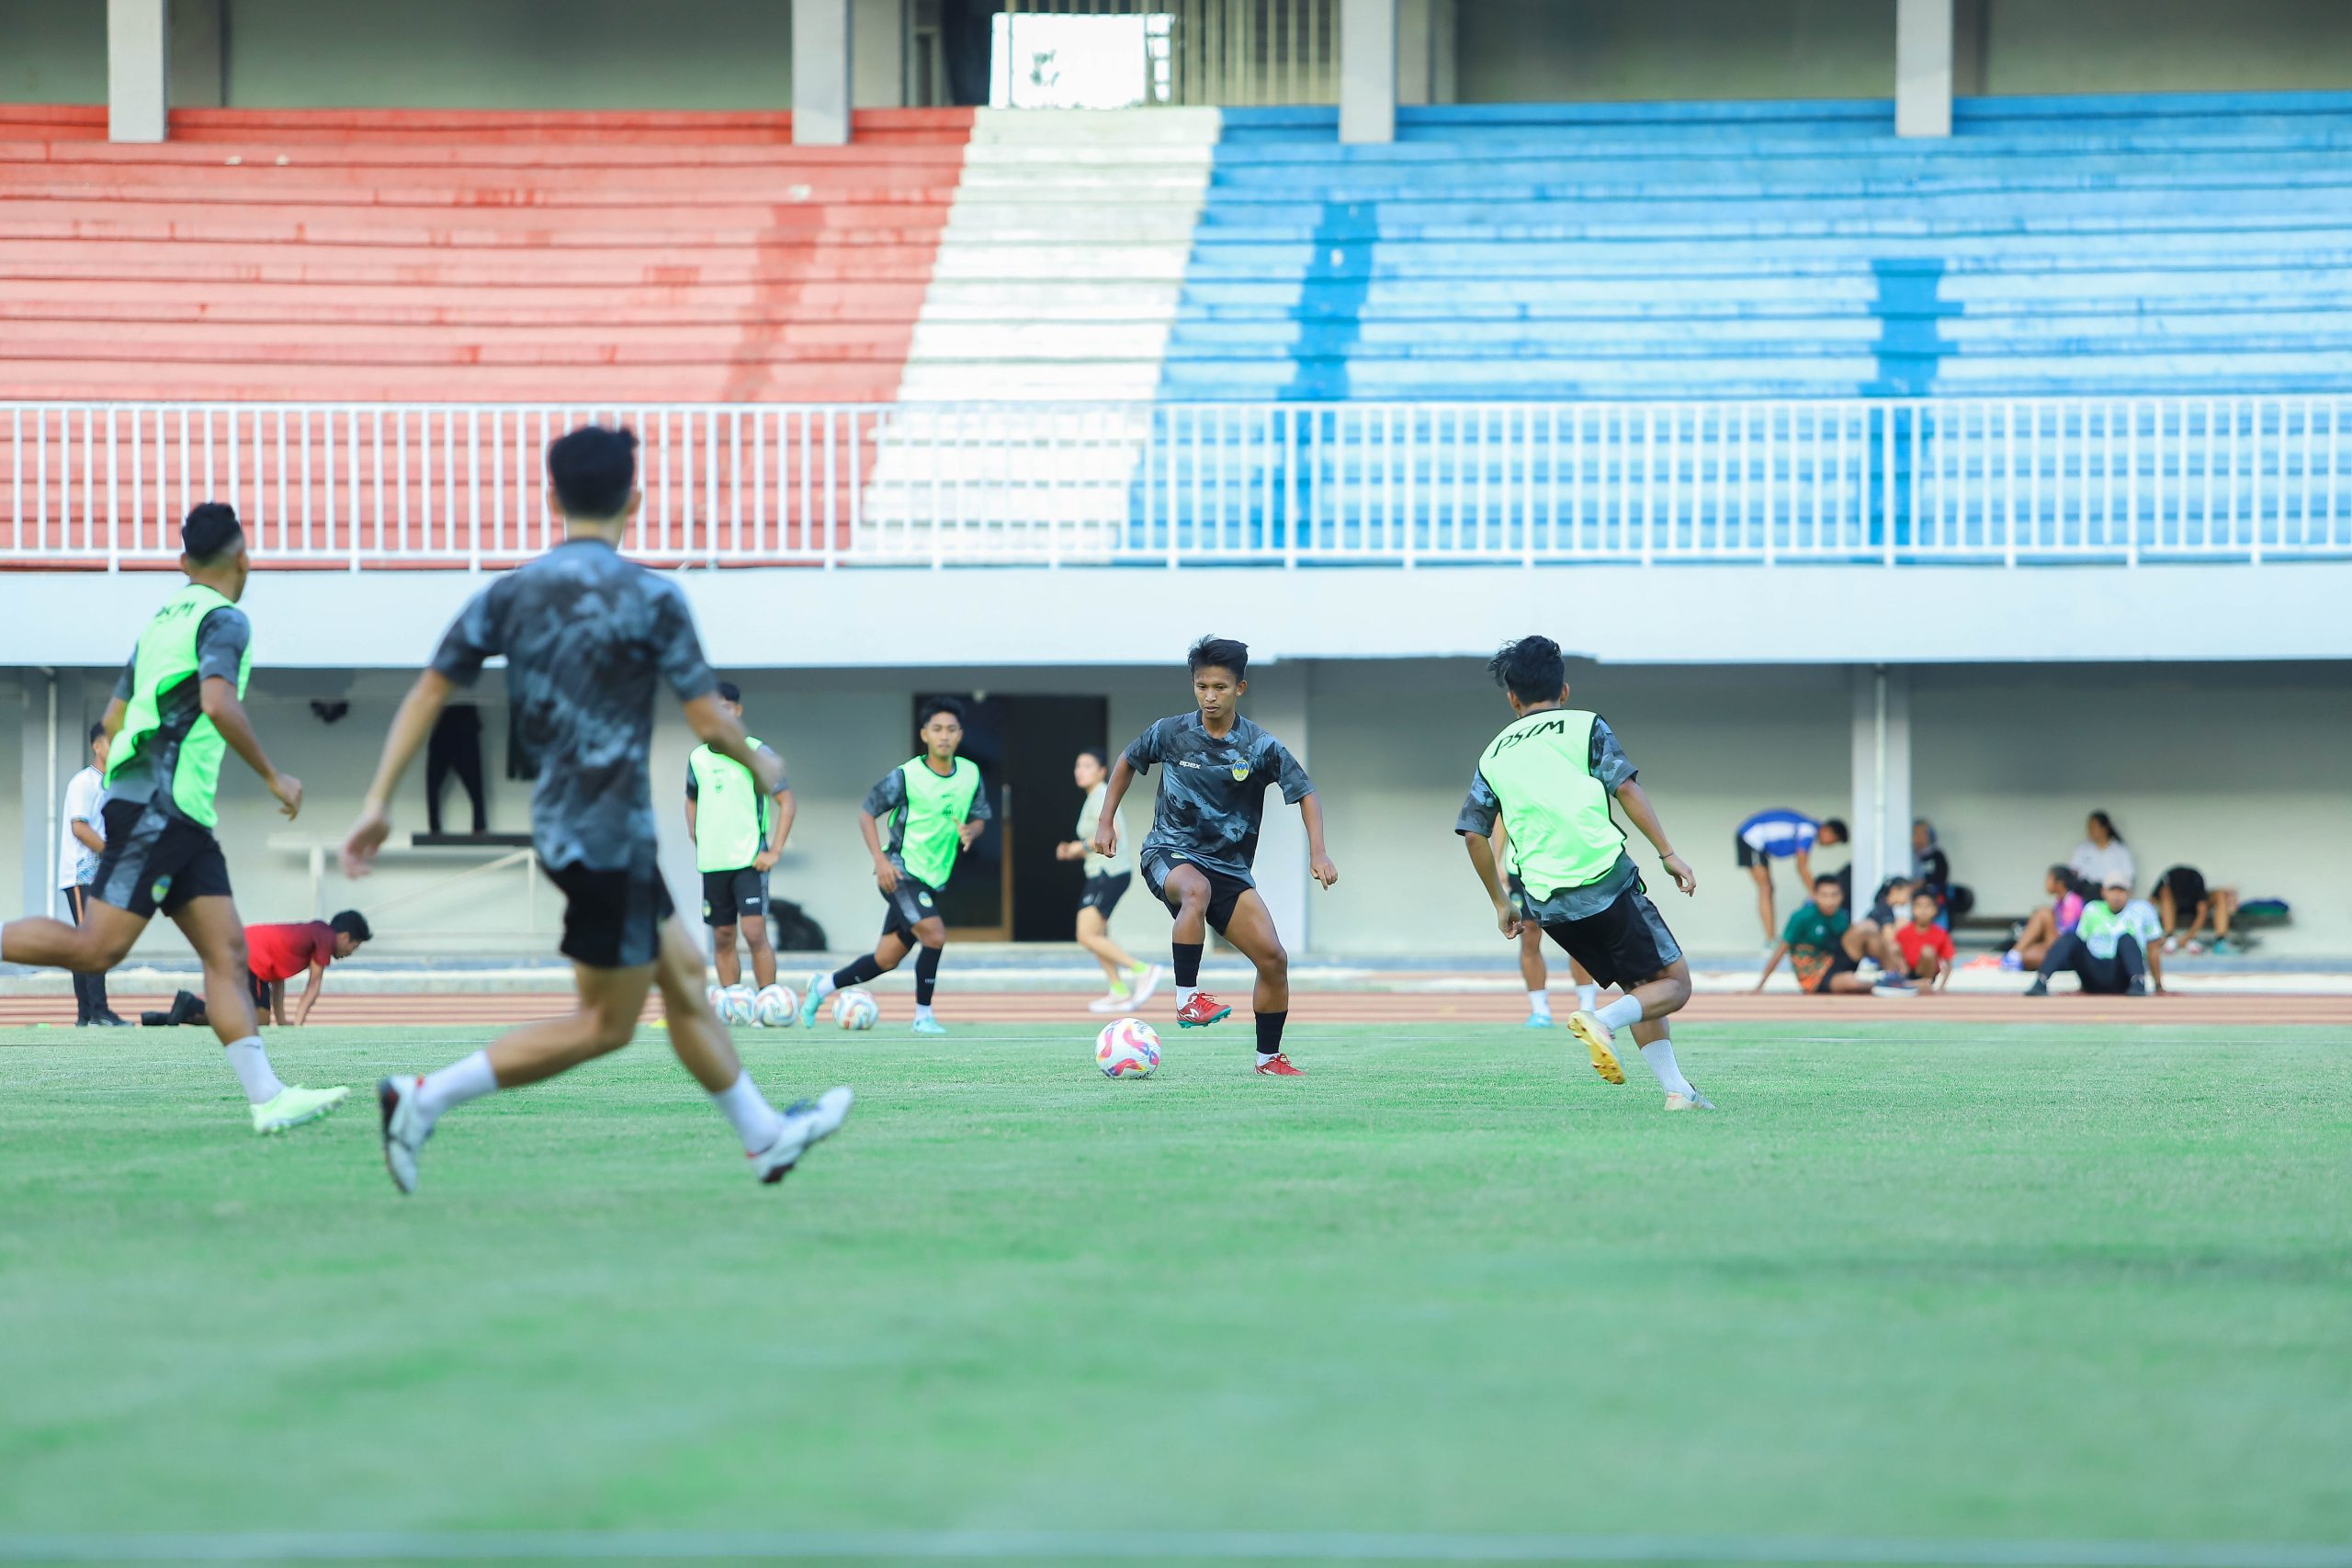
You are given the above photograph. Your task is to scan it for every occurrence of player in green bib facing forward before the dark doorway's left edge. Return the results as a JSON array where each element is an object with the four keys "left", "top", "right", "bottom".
[{"left": 799, "top": 696, "right": 992, "bottom": 1034}]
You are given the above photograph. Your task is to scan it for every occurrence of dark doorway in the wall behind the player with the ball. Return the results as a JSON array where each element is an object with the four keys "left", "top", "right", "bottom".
[{"left": 915, "top": 691, "right": 1110, "bottom": 942}]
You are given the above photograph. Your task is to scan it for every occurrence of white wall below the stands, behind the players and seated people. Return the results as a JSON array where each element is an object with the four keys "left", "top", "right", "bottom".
[{"left": 18, "top": 659, "right": 2352, "bottom": 957}]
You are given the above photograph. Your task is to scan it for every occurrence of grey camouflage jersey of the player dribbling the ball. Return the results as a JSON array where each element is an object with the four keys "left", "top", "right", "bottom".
[{"left": 1126, "top": 712, "right": 1315, "bottom": 886}]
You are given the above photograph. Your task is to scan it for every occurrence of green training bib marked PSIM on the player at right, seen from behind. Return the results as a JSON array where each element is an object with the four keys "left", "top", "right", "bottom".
[{"left": 1477, "top": 707, "right": 1625, "bottom": 898}]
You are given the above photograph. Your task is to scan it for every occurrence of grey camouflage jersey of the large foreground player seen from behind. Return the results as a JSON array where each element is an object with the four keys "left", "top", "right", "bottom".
[{"left": 433, "top": 538, "right": 718, "bottom": 874}]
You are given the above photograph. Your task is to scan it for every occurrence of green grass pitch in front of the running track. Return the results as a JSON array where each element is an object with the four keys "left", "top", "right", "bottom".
[{"left": 0, "top": 1018, "right": 2352, "bottom": 1542}]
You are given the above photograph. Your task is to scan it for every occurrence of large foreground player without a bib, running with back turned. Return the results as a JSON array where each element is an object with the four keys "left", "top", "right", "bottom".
[{"left": 344, "top": 425, "right": 852, "bottom": 1192}]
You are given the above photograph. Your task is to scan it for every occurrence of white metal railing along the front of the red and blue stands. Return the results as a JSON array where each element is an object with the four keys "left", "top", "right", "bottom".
[{"left": 0, "top": 395, "right": 2352, "bottom": 571}]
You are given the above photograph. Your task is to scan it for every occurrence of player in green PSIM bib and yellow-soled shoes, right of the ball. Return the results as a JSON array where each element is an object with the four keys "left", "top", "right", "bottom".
[{"left": 1453, "top": 637, "right": 1714, "bottom": 1110}]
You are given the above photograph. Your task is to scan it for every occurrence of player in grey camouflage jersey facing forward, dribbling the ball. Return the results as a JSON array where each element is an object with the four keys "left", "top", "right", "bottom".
[{"left": 1093, "top": 637, "right": 1339, "bottom": 1079}]
